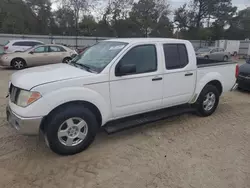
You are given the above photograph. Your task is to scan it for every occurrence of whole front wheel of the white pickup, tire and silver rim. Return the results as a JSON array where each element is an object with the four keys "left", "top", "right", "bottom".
[{"left": 45, "top": 105, "right": 98, "bottom": 155}]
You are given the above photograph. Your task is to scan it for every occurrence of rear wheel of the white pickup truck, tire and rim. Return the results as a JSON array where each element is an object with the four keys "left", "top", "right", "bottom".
[{"left": 195, "top": 85, "right": 220, "bottom": 117}]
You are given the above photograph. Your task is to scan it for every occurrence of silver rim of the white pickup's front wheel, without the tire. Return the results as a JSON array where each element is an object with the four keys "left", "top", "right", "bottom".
[{"left": 57, "top": 117, "right": 88, "bottom": 146}]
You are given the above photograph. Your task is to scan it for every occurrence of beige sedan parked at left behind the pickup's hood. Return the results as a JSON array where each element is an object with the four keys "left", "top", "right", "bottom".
[{"left": 0, "top": 44, "right": 77, "bottom": 69}]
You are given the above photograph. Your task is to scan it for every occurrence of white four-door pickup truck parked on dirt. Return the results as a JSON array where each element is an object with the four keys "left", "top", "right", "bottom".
[{"left": 6, "top": 38, "right": 238, "bottom": 155}]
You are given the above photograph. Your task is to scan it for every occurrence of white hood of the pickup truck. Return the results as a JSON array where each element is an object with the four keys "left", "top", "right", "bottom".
[{"left": 11, "top": 63, "right": 93, "bottom": 90}]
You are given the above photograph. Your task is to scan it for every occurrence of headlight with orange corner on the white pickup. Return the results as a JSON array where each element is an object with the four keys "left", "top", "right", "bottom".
[{"left": 17, "top": 90, "right": 42, "bottom": 107}]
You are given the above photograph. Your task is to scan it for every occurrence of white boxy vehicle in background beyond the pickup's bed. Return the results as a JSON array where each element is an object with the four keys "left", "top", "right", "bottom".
[{"left": 216, "top": 40, "right": 240, "bottom": 56}]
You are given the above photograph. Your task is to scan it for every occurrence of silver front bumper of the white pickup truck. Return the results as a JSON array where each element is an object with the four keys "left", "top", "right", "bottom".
[{"left": 6, "top": 106, "right": 43, "bottom": 135}]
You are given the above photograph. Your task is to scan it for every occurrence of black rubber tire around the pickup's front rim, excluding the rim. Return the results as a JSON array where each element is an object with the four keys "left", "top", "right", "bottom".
[{"left": 44, "top": 104, "right": 99, "bottom": 155}]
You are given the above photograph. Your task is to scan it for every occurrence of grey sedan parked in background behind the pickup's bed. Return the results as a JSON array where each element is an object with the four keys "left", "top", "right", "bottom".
[{"left": 196, "top": 47, "right": 230, "bottom": 61}]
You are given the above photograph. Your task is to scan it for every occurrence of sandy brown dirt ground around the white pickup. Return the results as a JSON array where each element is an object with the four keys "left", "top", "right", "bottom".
[{"left": 0, "top": 68, "right": 250, "bottom": 188}]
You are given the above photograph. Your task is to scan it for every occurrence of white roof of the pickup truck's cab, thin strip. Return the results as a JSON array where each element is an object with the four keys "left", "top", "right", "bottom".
[{"left": 107, "top": 38, "right": 187, "bottom": 43}]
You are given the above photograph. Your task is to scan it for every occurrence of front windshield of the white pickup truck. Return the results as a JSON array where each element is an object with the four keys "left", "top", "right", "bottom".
[{"left": 71, "top": 41, "right": 127, "bottom": 73}]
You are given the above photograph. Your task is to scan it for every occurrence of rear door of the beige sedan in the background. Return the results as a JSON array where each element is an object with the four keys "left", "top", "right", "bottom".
[{"left": 49, "top": 45, "right": 67, "bottom": 63}]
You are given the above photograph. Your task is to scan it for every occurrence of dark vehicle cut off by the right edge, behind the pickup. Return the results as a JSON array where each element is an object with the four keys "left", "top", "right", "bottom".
[{"left": 237, "top": 58, "right": 250, "bottom": 91}]
